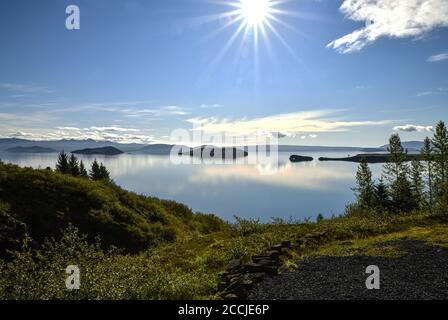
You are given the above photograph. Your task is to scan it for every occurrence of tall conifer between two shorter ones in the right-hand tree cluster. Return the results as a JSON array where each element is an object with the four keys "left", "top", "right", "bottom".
[{"left": 384, "top": 134, "right": 415, "bottom": 212}]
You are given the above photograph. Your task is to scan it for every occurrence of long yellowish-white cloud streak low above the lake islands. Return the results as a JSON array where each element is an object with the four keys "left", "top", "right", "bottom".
[{"left": 188, "top": 110, "right": 392, "bottom": 136}]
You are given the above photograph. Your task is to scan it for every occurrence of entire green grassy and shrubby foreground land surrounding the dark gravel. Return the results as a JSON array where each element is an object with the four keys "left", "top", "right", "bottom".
[{"left": 0, "top": 165, "right": 448, "bottom": 299}]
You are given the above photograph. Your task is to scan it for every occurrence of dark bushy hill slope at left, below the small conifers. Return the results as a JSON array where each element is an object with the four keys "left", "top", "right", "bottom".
[{"left": 0, "top": 164, "right": 225, "bottom": 253}]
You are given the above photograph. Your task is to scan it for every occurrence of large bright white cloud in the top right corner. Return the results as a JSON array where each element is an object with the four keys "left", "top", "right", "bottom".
[{"left": 327, "top": 0, "right": 448, "bottom": 53}]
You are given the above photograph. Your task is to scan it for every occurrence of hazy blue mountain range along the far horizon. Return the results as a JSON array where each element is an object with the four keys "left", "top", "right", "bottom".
[{"left": 0, "top": 138, "right": 423, "bottom": 155}]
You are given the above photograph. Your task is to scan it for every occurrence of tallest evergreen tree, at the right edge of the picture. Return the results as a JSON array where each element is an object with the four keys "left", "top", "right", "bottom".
[{"left": 432, "top": 121, "right": 448, "bottom": 212}]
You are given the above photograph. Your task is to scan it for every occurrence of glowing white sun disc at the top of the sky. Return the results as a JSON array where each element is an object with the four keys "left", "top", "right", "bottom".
[{"left": 237, "top": 0, "right": 274, "bottom": 29}]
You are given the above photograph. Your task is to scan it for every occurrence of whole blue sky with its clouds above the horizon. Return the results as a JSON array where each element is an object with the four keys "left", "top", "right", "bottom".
[{"left": 0, "top": 0, "right": 448, "bottom": 146}]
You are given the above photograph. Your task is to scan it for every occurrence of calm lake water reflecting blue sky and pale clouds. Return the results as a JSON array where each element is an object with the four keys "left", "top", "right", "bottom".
[{"left": 0, "top": 152, "right": 382, "bottom": 222}]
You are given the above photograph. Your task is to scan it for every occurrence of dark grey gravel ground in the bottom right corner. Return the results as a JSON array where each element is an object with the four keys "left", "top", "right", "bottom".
[{"left": 249, "top": 240, "right": 448, "bottom": 300}]
